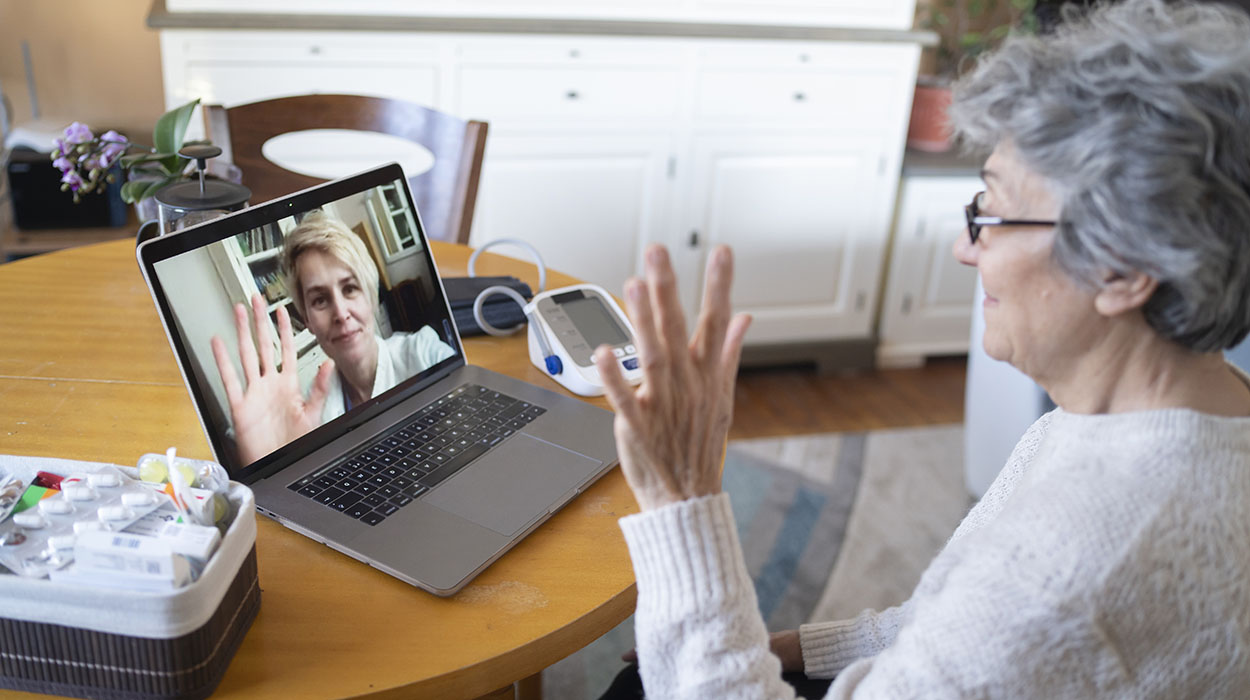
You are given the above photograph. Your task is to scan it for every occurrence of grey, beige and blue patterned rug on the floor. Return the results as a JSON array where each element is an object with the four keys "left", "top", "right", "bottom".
[{"left": 543, "top": 425, "right": 971, "bottom": 700}]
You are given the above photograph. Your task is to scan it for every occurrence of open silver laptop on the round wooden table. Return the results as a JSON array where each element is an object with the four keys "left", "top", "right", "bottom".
[{"left": 138, "top": 164, "right": 616, "bottom": 595}]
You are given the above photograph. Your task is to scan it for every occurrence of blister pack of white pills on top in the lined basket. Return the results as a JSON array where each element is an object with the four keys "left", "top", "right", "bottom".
[{"left": 0, "top": 468, "right": 169, "bottom": 578}]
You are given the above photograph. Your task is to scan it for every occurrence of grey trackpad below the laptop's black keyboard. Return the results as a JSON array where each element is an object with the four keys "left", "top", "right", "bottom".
[{"left": 424, "top": 433, "right": 603, "bottom": 535}]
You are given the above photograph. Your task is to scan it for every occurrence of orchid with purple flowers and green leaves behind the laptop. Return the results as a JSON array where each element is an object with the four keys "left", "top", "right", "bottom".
[{"left": 53, "top": 100, "right": 203, "bottom": 204}]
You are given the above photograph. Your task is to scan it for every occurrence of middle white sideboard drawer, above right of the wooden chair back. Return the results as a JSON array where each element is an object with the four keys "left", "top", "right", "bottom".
[{"left": 458, "top": 68, "right": 678, "bottom": 120}]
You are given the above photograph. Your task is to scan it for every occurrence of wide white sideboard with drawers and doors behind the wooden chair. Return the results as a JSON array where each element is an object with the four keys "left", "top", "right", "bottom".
[{"left": 156, "top": 6, "right": 930, "bottom": 345}]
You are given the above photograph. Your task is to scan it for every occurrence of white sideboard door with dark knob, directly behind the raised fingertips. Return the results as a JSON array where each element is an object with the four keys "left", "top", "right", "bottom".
[{"left": 679, "top": 131, "right": 894, "bottom": 344}]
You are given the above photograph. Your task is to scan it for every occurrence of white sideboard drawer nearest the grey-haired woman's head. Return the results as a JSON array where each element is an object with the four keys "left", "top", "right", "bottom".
[{"left": 695, "top": 70, "right": 901, "bottom": 129}]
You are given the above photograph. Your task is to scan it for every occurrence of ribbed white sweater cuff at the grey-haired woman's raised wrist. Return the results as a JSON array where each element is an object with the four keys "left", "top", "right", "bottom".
[{"left": 620, "top": 493, "right": 755, "bottom": 619}]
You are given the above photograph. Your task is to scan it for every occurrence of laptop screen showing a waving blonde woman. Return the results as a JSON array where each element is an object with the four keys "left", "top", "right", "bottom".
[{"left": 140, "top": 166, "right": 463, "bottom": 479}]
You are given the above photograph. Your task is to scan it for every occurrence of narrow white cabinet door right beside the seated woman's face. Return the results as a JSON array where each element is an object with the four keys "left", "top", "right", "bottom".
[{"left": 878, "top": 176, "right": 983, "bottom": 366}]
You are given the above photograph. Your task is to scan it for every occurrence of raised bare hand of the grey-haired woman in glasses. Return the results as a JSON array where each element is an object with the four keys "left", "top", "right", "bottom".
[{"left": 595, "top": 245, "right": 751, "bottom": 510}]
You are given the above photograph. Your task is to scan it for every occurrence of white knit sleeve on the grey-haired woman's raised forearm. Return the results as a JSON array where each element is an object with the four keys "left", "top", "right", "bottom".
[{"left": 620, "top": 494, "right": 794, "bottom": 700}]
